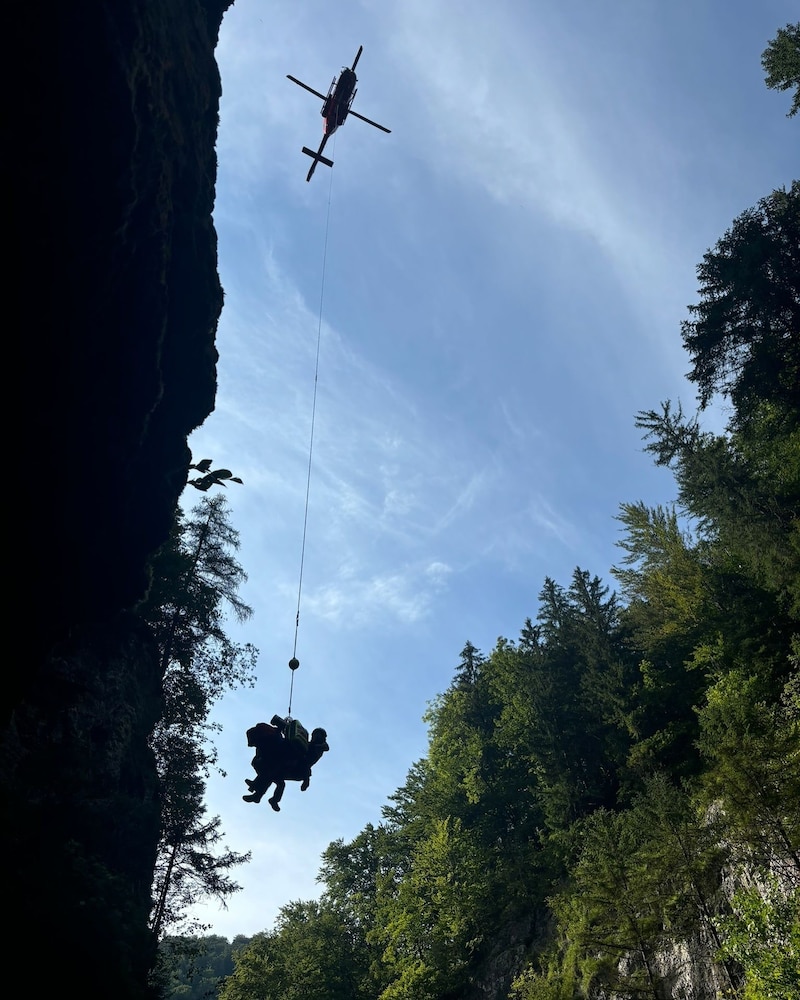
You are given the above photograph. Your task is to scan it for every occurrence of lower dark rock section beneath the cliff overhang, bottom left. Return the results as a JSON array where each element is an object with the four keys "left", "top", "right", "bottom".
[{"left": 0, "top": 615, "right": 161, "bottom": 997}]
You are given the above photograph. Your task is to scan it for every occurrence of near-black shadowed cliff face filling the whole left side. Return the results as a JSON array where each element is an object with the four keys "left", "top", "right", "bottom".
[{"left": 5, "top": 0, "right": 229, "bottom": 998}]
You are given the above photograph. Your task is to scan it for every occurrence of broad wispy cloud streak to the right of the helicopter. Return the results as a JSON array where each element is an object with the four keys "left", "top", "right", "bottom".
[{"left": 372, "top": 0, "right": 704, "bottom": 365}]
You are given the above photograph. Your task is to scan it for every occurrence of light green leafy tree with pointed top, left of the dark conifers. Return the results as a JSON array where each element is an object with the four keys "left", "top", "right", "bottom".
[{"left": 354, "top": 643, "right": 524, "bottom": 1000}]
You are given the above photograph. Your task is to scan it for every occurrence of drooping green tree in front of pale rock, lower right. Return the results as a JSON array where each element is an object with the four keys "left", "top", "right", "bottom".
[{"left": 544, "top": 774, "right": 739, "bottom": 1000}]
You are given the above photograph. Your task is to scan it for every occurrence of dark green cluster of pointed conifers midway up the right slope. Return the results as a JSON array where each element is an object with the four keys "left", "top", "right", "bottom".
[{"left": 486, "top": 569, "right": 635, "bottom": 833}]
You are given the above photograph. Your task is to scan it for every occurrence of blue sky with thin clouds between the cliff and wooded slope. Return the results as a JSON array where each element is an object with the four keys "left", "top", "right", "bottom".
[{"left": 184, "top": 0, "right": 797, "bottom": 938}]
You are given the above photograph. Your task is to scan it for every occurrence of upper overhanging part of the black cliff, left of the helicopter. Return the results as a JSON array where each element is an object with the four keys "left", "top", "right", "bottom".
[{"left": 7, "top": 0, "right": 228, "bottom": 699}]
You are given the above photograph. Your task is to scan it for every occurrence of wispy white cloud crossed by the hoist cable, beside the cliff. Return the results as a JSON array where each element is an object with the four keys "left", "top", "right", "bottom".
[{"left": 193, "top": 239, "right": 556, "bottom": 628}]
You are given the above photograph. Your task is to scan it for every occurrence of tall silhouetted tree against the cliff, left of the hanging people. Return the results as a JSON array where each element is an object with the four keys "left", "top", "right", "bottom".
[{"left": 139, "top": 495, "right": 256, "bottom": 938}]
